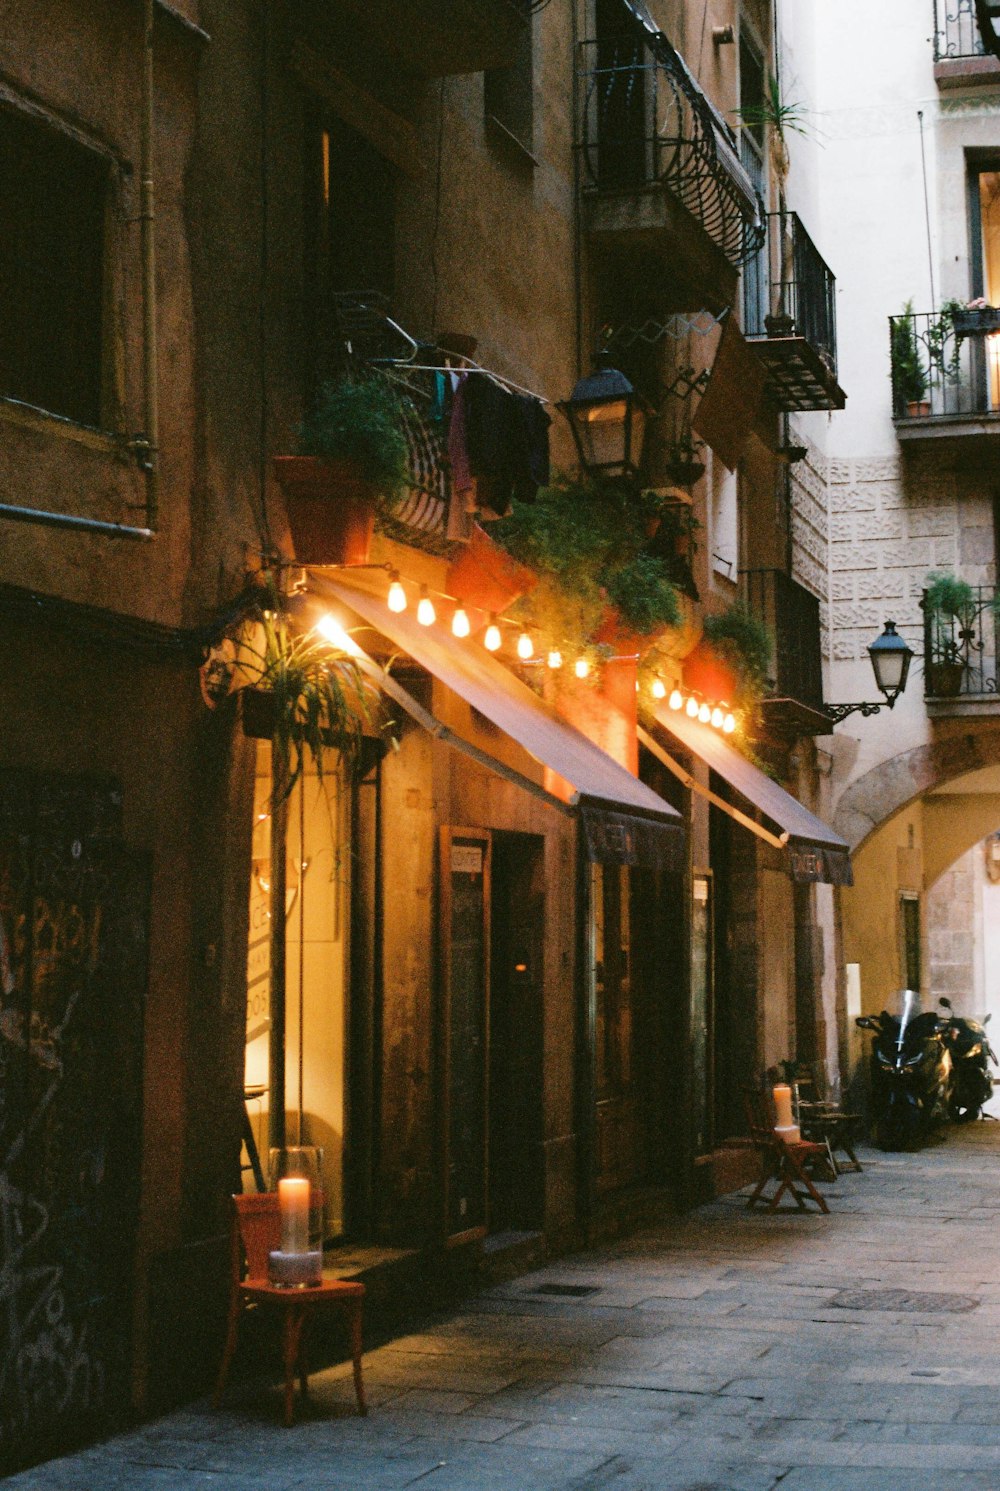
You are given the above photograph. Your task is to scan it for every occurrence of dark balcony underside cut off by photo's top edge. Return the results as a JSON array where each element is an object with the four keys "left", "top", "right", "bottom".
[{"left": 330, "top": 0, "right": 537, "bottom": 78}]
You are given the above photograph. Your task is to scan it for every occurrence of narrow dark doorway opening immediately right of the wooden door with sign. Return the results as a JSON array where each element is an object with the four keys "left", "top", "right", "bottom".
[{"left": 489, "top": 833, "right": 545, "bottom": 1232}]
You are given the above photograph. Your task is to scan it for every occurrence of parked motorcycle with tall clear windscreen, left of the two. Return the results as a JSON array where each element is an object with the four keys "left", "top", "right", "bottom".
[{"left": 854, "top": 989, "right": 954, "bottom": 1150}]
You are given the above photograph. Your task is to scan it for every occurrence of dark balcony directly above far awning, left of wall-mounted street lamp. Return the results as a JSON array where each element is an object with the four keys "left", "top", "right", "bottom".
[{"left": 741, "top": 570, "right": 832, "bottom": 737}]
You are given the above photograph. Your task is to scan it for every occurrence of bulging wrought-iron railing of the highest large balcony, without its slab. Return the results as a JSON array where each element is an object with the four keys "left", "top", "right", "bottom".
[{"left": 578, "top": 21, "right": 765, "bottom": 267}]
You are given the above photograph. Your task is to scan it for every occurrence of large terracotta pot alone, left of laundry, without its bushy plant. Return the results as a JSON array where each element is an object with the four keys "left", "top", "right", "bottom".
[{"left": 273, "top": 456, "right": 377, "bottom": 565}]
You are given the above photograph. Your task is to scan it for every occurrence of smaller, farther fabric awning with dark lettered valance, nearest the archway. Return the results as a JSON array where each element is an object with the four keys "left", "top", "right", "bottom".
[{"left": 656, "top": 704, "right": 854, "bottom": 886}]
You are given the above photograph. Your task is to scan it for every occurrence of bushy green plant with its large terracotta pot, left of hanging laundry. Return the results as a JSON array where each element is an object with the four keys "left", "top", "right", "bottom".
[{"left": 273, "top": 374, "right": 407, "bottom": 565}]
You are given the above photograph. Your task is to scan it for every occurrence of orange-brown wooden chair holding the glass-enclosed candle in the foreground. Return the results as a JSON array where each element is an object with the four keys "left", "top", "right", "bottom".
[{"left": 213, "top": 1191, "right": 368, "bottom": 1427}]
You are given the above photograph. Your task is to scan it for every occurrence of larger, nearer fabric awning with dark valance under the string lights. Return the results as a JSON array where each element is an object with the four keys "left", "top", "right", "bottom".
[{"left": 311, "top": 574, "right": 684, "bottom": 869}]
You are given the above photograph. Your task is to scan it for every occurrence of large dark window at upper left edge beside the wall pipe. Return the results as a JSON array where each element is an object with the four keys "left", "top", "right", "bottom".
[{"left": 0, "top": 109, "right": 109, "bottom": 425}]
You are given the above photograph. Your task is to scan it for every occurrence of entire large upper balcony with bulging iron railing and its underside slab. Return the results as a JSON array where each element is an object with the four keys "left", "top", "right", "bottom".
[{"left": 577, "top": 15, "right": 763, "bottom": 309}]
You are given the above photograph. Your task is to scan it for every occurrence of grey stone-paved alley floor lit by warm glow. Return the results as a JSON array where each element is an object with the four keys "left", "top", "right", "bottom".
[{"left": 13, "top": 1123, "right": 1000, "bottom": 1491}]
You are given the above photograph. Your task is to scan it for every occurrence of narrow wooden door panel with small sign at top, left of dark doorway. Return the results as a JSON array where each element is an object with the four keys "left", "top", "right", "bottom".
[{"left": 440, "top": 828, "right": 492, "bottom": 1243}]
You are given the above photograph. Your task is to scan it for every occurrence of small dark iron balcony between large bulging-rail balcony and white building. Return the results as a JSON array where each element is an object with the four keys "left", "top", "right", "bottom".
[{"left": 744, "top": 212, "right": 846, "bottom": 412}]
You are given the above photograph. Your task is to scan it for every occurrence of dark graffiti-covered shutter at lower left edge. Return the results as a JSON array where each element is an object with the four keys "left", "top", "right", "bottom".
[{"left": 0, "top": 774, "right": 146, "bottom": 1470}]
